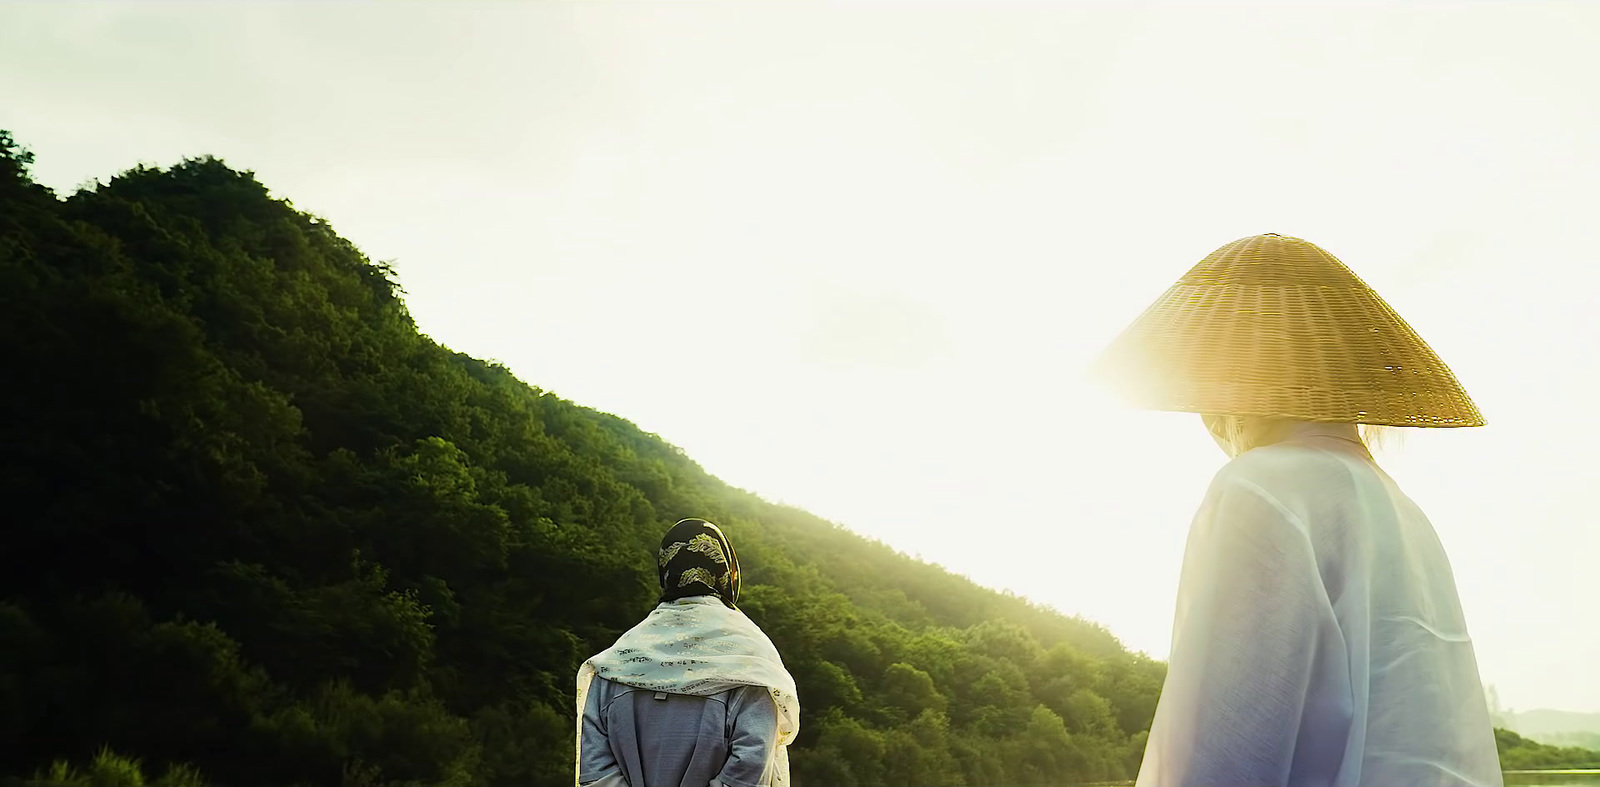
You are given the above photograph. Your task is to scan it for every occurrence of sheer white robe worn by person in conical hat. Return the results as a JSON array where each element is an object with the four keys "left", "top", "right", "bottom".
[{"left": 1138, "top": 424, "right": 1502, "bottom": 787}]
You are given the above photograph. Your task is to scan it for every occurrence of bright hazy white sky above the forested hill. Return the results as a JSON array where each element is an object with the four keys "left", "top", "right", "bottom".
[{"left": 0, "top": 0, "right": 1600, "bottom": 710}]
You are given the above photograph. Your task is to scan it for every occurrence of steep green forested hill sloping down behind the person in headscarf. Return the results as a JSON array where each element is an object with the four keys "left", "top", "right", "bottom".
[{"left": 0, "top": 136, "right": 1163, "bottom": 787}]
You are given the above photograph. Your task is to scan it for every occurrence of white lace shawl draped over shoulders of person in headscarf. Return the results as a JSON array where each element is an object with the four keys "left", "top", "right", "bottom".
[{"left": 574, "top": 597, "right": 800, "bottom": 787}]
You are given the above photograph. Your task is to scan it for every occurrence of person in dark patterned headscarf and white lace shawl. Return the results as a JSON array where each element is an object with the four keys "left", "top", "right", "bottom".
[{"left": 576, "top": 518, "right": 800, "bottom": 787}]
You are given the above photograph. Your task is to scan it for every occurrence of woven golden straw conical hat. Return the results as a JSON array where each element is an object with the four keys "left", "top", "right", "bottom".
[{"left": 1096, "top": 235, "right": 1483, "bottom": 427}]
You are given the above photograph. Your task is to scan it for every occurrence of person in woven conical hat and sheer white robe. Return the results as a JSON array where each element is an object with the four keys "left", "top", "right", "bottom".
[{"left": 1098, "top": 234, "right": 1502, "bottom": 787}]
